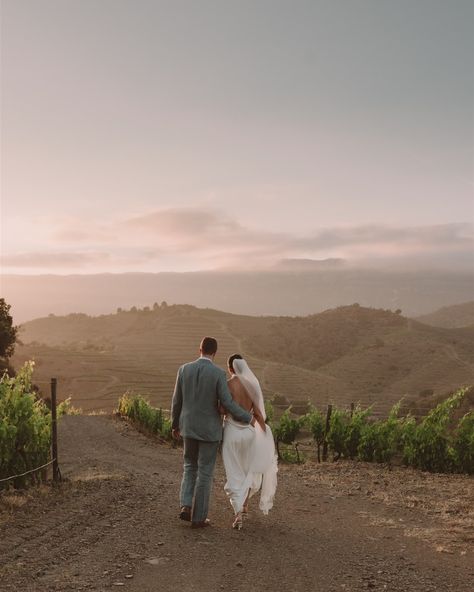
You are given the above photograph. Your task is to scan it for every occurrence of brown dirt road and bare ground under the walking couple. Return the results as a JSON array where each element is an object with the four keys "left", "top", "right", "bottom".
[{"left": 0, "top": 416, "right": 474, "bottom": 592}]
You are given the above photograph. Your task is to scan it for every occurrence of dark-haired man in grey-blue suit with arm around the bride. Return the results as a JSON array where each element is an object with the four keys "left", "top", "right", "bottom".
[{"left": 171, "top": 337, "right": 255, "bottom": 528}]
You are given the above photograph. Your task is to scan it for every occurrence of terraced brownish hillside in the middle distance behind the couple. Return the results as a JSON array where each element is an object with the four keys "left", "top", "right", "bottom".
[{"left": 13, "top": 305, "right": 474, "bottom": 413}]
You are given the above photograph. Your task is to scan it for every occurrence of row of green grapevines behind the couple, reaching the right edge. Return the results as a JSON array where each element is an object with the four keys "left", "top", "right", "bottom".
[{"left": 118, "top": 389, "right": 474, "bottom": 474}]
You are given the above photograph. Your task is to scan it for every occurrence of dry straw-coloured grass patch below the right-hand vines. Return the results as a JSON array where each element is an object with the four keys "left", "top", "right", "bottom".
[{"left": 300, "top": 461, "right": 474, "bottom": 555}]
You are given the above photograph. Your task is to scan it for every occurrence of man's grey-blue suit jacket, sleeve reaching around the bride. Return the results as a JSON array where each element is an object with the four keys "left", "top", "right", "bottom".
[{"left": 171, "top": 358, "right": 252, "bottom": 442}]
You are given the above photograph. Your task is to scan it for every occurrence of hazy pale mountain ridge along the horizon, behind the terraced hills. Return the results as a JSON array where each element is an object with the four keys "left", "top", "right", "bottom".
[{"left": 1, "top": 268, "right": 474, "bottom": 323}]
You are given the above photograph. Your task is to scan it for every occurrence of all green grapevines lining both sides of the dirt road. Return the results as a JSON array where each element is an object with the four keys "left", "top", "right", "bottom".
[{"left": 0, "top": 354, "right": 474, "bottom": 498}]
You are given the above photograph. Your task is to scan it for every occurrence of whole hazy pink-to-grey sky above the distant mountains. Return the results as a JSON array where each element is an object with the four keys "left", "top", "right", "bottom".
[{"left": 0, "top": 0, "right": 474, "bottom": 274}]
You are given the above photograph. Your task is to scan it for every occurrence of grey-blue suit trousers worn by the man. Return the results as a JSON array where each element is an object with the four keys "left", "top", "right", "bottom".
[{"left": 180, "top": 438, "right": 219, "bottom": 522}]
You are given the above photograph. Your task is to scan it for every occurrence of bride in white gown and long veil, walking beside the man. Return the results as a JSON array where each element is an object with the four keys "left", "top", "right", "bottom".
[{"left": 222, "top": 354, "right": 278, "bottom": 530}]
